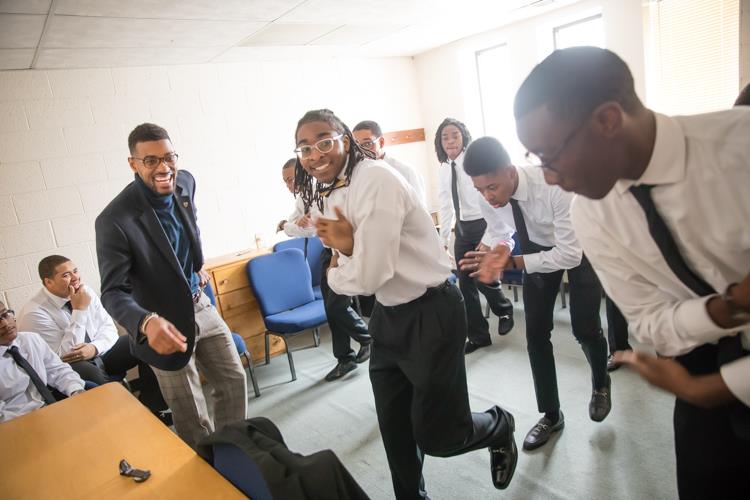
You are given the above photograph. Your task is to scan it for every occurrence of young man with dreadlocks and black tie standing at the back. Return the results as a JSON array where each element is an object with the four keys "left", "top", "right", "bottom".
[{"left": 435, "top": 118, "right": 513, "bottom": 354}]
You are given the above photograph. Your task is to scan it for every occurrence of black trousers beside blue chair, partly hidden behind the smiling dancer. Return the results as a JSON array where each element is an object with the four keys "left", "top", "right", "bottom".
[{"left": 320, "top": 248, "right": 372, "bottom": 363}]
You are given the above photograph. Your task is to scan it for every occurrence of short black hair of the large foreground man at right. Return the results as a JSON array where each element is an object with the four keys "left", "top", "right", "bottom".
[{"left": 513, "top": 47, "right": 643, "bottom": 120}]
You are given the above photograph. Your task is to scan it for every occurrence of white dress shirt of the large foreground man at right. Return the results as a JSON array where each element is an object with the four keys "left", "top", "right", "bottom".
[{"left": 572, "top": 106, "right": 750, "bottom": 406}]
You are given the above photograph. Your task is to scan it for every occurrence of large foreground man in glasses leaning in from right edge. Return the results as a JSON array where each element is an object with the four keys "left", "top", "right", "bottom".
[{"left": 514, "top": 47, "right": 750, "bottom": 499}]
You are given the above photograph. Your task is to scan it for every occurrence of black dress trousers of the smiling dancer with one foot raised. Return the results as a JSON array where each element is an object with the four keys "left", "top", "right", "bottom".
[{"left": 370, "top": 283, "right": 510, "bottom": 500}]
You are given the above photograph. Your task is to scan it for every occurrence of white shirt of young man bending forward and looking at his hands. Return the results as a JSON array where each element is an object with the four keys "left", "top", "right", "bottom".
[{"left": 480, "top": 167, "right": 583, "bottom": 273}]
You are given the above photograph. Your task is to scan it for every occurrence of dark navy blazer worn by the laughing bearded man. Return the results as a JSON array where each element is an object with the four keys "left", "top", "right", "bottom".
[{"left": 96, "top": 170, "right": 203, "bottom": 370}]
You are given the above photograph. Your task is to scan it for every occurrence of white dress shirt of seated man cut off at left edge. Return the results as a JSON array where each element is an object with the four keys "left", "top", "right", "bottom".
[{"left": 0, "top": 332, "right": 83, "bottom": 422}]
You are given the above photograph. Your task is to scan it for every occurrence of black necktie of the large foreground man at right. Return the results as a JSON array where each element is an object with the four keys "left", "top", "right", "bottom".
[{"left": 630, "top": 184, "right": 743, "bottom": 365}]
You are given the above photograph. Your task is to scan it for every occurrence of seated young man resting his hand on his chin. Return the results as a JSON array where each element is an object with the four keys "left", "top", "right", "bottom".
[{"left": 18, "top": 255, "right": 167, "bottom": 414}]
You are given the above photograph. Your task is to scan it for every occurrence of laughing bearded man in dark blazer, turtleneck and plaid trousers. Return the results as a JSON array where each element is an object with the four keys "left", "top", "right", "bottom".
[{"left": 96, "top": 123, "right": 247, "bottom": 448}]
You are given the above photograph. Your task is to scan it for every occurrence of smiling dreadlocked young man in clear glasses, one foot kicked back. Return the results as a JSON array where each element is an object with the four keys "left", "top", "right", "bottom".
[{"left": 295, "top": 110, "right": 518, "bottom": 499}]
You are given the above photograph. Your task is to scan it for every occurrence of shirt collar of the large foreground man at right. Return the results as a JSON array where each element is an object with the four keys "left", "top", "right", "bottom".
[{"left": 615, "top": 113, "right": 687, "bottom": 194}]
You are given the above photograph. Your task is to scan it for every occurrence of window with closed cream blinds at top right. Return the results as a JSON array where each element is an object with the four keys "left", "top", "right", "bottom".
[{"left": 643, "top": 0, "right": 740, "bottom": 115}]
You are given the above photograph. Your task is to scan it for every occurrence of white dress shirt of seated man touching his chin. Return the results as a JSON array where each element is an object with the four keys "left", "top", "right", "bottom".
[{"left": 18, "top": 285, "right": 119, "bottom": 356}]
